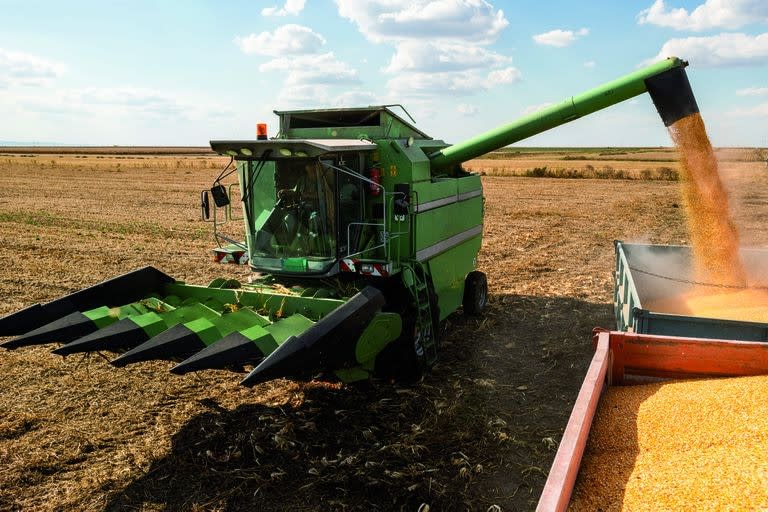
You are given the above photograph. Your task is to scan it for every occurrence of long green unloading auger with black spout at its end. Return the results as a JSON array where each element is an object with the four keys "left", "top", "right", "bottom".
[{"left": 429, "top": 57, "right": 699, "bottom": 169}]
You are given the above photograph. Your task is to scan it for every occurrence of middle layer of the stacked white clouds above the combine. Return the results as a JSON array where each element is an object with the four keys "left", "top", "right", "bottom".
[{"left": 384, "top": 41, "right": 512, "bottom": 73}]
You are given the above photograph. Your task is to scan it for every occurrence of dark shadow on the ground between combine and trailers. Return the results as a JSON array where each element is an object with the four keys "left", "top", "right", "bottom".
[{"left": 106, "top": 295, "right": 613, "bottom": 511}]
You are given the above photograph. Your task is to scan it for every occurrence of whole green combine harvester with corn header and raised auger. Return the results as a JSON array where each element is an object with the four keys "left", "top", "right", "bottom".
[{"left": 0, "top": 58, "right": 698, "bottom": 386}]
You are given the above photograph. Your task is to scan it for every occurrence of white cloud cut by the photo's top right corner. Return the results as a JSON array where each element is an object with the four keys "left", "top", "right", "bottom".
[{"left": 637, "top": 0, "right": 768, "bottom": 32}]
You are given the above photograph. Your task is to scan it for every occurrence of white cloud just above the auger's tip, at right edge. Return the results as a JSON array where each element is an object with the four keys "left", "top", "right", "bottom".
[{"left": 647, "top": 32, "right": 768, "bottom": 67}]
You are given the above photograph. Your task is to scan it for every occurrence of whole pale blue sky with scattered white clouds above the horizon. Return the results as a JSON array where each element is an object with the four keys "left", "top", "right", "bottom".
[{"left": 0, "top": 0, "right": 768, "bottom": 147}]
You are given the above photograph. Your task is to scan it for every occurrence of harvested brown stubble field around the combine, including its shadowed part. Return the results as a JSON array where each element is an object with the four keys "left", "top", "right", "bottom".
[{"left": 0, "top": 150, "right": 768, "bottom": 511}]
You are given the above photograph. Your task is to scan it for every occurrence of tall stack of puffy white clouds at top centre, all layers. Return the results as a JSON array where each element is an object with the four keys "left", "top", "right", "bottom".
[{"left": 335, "top": 0, "right": 519, "bottom": 98}]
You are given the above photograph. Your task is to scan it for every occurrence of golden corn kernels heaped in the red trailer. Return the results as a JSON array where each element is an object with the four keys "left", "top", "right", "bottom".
[{"left": 569, "top": 376, "right": 768, "bottom": 512}]
